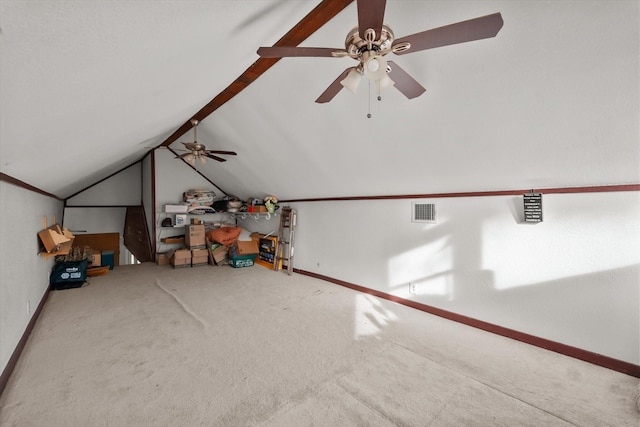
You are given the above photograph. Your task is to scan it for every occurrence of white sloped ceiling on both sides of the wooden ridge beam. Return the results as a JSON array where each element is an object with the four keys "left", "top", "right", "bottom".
[{"left": 0, "top": 0, "right": 640, "bottom": 199}]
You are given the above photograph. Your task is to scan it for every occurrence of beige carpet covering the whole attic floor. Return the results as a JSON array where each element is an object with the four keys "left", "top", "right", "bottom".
[{"left": 0, "top": 264, "right": 640, "bottom": 427}]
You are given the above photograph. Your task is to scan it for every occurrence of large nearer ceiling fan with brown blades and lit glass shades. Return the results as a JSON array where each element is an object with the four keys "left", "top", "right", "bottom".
[{"left": 258, "top": 0, "right": 503, "bottom": 103}]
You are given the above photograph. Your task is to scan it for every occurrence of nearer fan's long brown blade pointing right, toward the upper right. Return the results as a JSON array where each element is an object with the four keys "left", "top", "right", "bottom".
[{"left": 393, "top": 13, "right": 503, "bottom": 55}]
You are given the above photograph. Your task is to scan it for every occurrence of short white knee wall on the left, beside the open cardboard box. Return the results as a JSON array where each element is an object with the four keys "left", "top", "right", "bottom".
[{"left": 0, "top": 181, "right": 63, "bottom": 372}]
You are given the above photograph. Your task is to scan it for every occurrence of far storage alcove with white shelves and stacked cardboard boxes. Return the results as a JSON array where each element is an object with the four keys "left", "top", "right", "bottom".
[{"left": 148, "top": 149, "right": 292, "bottom": 270}]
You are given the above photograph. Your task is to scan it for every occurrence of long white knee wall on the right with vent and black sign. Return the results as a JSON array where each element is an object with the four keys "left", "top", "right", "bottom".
[{"left": 292, "top": 192, "right": 640, "bottom": 364}]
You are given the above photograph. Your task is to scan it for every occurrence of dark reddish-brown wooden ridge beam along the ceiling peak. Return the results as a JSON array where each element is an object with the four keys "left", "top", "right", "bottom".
[{"left": 159, "top": 0, "right": 353, "bottom": 147}]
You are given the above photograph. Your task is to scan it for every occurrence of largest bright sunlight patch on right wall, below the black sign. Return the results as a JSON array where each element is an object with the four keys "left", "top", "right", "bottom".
[{"left": 481, "top": 194, "right": 640, "bottom": 289}]
